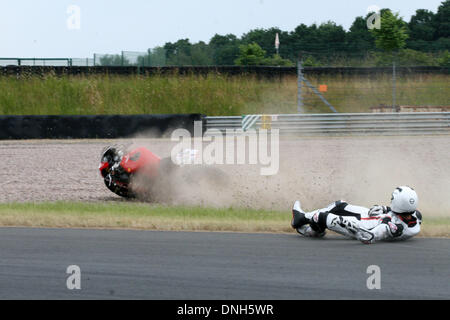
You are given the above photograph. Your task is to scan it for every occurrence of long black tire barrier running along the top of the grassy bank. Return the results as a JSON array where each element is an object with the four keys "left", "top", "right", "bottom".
[{"left": 0, "top": 66, "right": 450, "bottom": 79}]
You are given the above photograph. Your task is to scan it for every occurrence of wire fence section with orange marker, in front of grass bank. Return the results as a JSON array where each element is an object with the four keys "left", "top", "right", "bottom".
[{"left": 297, "top": 64, "right": 450, "bottom": 113}]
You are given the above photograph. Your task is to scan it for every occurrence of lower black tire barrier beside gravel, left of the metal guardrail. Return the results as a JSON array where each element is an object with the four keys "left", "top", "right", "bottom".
[{"left": 0, "top": 114, "right": 205, "bottom": 140}]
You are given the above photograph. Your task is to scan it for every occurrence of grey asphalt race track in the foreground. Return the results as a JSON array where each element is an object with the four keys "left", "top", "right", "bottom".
[{"left": 0, "top": 228, "right": 450, "bottom": 300}]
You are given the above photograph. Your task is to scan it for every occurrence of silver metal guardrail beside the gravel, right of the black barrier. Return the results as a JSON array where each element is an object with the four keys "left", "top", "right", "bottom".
[{"left": 205, "top": 112, "right": 450, "bottom": 135}]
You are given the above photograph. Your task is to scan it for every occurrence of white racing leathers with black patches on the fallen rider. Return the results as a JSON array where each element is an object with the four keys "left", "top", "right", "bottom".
[{"left": 298, "top": 201, "right": 422, "bottom": 243}]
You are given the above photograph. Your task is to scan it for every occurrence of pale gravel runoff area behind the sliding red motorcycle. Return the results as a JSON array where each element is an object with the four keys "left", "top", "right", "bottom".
[{"left": 0, "top": 136, "right": 450, "bottom": 216}]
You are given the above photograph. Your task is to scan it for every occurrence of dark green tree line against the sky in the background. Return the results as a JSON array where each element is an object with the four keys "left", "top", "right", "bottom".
[{"left": 100, "top": 0, "right": 450, "bottom": 66}]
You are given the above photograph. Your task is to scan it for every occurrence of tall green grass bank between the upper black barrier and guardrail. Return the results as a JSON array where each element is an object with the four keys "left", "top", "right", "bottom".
[{"left": 0, "top": 74, "right": 450, "bottom": 116}]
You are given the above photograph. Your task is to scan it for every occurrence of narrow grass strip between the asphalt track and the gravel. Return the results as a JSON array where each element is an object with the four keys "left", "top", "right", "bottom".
[{"left": 0, "top": 202, "right": 450, "bottom": 237}]
